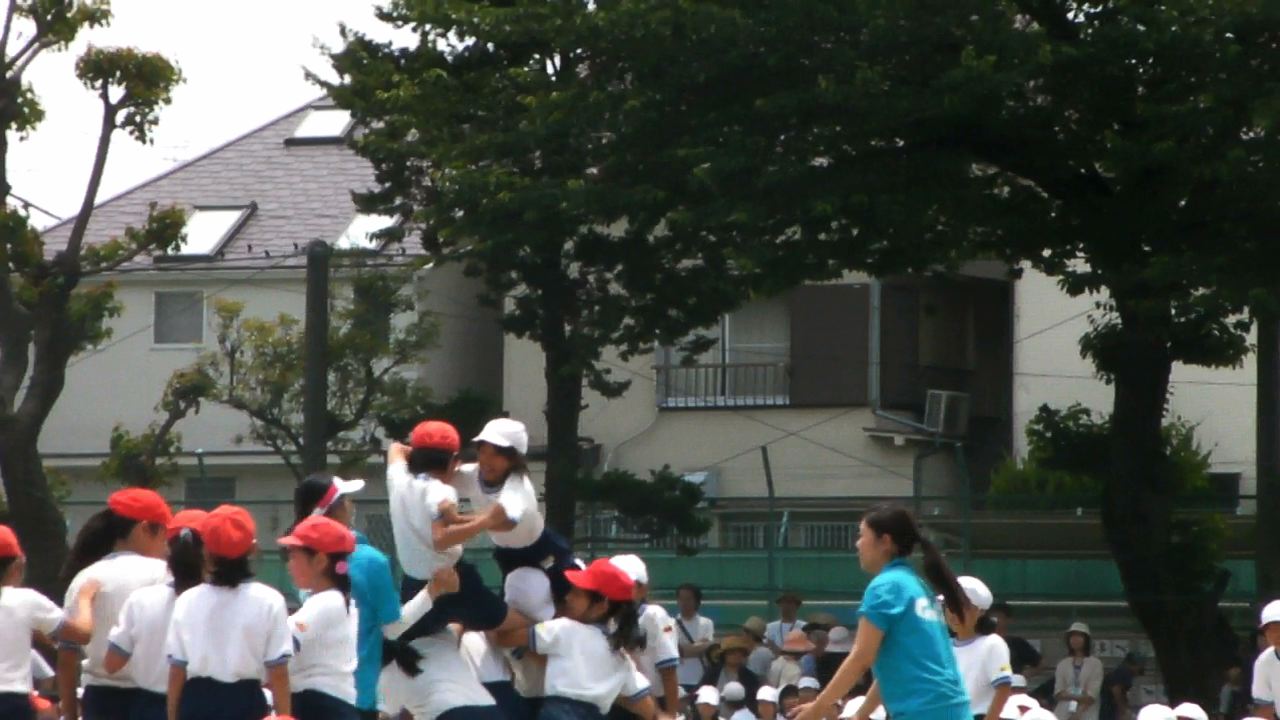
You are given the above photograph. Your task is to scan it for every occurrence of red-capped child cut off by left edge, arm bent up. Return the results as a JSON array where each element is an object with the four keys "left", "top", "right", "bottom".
[{"left": 0, "top": 525, "right": 99, "bottom": 720}]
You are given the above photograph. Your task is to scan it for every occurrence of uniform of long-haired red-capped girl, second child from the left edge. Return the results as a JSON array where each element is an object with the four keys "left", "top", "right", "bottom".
[{"left": 59, "top": 552, "right": 169, "bottom": 720}]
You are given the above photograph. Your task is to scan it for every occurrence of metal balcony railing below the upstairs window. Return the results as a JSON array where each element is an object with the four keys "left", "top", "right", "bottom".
[{"left": 657, "top": 363, "right": 791, "bottom": 407}]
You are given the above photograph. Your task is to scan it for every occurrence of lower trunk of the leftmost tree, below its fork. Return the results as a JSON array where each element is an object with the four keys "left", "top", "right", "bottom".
[{"left": 0, "top": 432, "right": 67, "bottom": 601}]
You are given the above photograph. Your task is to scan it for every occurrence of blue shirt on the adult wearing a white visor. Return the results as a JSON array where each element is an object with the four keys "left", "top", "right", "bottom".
[{"left": 347, "top": 533, "right": 401, "bottom": 710}]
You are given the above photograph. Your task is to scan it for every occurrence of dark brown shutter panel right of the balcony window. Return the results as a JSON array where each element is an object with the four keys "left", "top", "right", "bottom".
[{"left": 791, "top": 284, "right": 870, "bottom": 406}]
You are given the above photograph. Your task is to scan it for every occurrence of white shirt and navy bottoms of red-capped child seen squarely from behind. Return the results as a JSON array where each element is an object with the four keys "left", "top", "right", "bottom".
[{"left": 165, "top": 582, "right": 293, "bottom": 720}]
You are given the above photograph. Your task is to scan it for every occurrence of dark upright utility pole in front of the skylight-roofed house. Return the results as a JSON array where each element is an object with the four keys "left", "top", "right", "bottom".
[{"left": 302, "top": 240, "right": 332, "bottom": 473}]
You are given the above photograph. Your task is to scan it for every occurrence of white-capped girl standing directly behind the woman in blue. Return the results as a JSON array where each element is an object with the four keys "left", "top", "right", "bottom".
[{"left": 945, "top": 575, "right": 1014, "bottom": 720}]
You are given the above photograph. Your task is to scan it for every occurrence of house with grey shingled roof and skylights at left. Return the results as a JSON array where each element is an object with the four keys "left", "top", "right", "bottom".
[{"left": 41, "top": 102, "right": 502, "bottom": 538}]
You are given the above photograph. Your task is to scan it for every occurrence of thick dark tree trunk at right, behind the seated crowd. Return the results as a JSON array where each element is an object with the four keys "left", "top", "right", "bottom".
[{"left": 1102, "top": 302, "right": 1234, "bottom": 707}]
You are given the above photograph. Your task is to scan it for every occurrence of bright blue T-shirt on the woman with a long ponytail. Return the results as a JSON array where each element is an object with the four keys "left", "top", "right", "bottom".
[{"left": 858, "top": 560, "right": 969, "bottom": 720}]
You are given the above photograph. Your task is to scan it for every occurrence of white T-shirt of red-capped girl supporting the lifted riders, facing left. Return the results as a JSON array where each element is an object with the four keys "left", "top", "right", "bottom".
[{"left": 529, "top": 618, "right": 649, "bottom": 712}]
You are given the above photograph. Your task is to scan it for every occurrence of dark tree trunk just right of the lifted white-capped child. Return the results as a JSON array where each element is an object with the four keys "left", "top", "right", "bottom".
[{"left": 543, "top": 341, "right": 584, "bottom": 541}]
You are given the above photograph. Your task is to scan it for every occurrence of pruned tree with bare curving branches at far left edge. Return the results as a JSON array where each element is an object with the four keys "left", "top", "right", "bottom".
[{"left": 0, "top": 0, "right": 186, "bottom": 592}]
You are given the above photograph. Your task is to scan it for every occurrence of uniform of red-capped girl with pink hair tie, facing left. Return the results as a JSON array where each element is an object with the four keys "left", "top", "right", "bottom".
[{"left": 289, "top": 589, "right": 360, "bottom": 720}]
